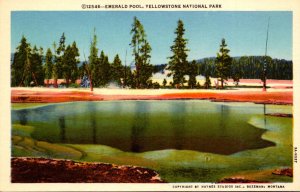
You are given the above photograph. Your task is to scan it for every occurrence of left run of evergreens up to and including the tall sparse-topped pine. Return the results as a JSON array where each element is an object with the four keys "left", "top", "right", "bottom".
[{"left": 11, "top": 17, "right": 157, "bottom": 90}]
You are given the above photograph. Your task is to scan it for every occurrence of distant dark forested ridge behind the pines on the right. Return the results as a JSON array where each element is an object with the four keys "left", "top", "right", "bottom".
[{"left": 154, "top": 56, "right": 293, "bottom": 80}]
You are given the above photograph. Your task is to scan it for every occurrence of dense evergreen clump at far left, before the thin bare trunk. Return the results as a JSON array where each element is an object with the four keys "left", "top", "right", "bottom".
[{"left": 11, "top": 33, "right": 79, "bottom": 87}]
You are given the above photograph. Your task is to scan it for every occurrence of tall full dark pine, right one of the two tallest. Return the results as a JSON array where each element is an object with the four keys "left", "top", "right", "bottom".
[{"left": 167, "top": 20, "right": 189, "bottom": 86}]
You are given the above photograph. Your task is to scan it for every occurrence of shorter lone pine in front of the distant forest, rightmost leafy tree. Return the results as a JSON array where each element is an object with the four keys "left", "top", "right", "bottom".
[{"left": 216, "top": 38, "right": 232, "bottom": 88}]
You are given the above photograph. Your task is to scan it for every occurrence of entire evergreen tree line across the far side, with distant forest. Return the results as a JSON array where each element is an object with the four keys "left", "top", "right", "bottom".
[{"left": 11, "top": 17, "right": 292, "bottom": 90}]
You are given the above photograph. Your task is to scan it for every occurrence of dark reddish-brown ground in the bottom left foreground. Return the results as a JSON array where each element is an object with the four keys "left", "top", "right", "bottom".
[{"left": 11, "top": 157, "right": 164, "bottom": 183}]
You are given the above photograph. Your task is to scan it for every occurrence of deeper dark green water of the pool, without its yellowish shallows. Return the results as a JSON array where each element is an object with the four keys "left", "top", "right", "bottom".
[{"left": 12, "top": 100, "right": 289, "bottom": 154}]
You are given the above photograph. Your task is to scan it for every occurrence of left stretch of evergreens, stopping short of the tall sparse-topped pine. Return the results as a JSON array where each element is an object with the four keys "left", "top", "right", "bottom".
[{"left": 11, "top": 33, "right": 143, "bottom": 87}]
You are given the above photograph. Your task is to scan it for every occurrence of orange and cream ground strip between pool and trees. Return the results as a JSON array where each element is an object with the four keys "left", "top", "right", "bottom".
[{"left": 11, "top": 79, "right": 293, "bottom": 104}]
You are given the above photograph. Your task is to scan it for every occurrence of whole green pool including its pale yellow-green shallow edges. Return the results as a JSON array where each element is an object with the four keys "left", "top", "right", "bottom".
[{"left": 11, "top": 100, "right": 293, "bottom": 182}]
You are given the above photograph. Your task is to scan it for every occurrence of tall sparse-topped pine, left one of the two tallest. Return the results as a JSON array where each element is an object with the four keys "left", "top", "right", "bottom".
[{"left": 130, "top": 17, "right": 153, "bottom": 88}]
